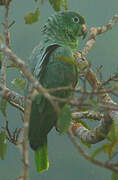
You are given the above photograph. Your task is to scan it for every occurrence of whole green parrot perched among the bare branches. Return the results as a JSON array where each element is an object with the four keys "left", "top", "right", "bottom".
[{"left": 28, "top": 11, "right": 87, "bottom": 173}]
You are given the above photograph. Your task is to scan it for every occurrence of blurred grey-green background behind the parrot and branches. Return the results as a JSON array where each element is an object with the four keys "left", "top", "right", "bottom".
[{"left": 0, "top": 0, "right": 118, "bottom": 180}]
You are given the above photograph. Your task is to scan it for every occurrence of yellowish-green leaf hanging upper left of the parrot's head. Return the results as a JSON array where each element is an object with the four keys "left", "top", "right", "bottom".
[{"left": 24, "top": 7, "right": 40, "bottom": 24}]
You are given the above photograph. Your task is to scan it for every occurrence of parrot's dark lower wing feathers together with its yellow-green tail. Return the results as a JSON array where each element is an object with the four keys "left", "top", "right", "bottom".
[{"left": 28, "top": 94, "right": 56, "bottom": 173}]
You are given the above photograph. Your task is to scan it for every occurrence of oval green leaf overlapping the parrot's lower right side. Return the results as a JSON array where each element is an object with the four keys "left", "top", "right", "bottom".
[{"left": 57, "top": 104, "right": 72, "bottom": 134}]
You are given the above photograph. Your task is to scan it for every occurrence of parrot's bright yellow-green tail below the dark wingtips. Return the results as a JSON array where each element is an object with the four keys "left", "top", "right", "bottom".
[{"left": 35, "top": 136, "right": 49, "bottom": 173}]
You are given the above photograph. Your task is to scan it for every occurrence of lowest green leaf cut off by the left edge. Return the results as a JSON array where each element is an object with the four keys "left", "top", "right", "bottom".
[{"left": 0, "top": 131, "right": 7, "bottom": 160}]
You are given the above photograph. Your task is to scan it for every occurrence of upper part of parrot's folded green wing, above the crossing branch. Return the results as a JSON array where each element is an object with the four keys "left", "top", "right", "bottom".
[{"left": 35, "top": 45, "right": 77, "bottom": 88}]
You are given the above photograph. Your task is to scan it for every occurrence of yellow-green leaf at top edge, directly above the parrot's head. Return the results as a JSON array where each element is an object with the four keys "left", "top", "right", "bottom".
[{"left": 49, "top": 0, "right": 68, "bottom": 11}]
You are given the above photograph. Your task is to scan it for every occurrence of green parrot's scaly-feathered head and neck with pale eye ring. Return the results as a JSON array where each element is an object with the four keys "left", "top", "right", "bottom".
[{"left": 42, "top": 11, "right": 87, "bottom": 50}]
